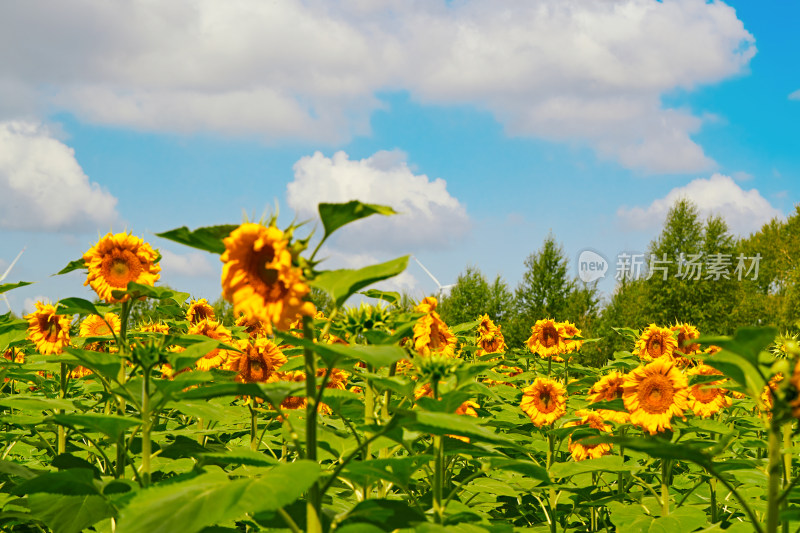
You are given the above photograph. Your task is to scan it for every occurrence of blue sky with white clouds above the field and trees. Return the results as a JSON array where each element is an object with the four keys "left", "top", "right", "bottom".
[{"left": 0, "top": 0, "right": 800, "bottom": 312}]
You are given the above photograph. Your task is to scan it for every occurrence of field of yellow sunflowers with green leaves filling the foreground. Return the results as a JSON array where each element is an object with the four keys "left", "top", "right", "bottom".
[{"left": 0, "top": 201, "right": 800, "bottom": 533}]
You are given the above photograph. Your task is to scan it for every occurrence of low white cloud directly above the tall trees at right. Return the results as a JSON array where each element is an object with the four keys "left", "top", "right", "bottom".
[{"left": 617, "top": 174, "right": 783, "bottom": 235}]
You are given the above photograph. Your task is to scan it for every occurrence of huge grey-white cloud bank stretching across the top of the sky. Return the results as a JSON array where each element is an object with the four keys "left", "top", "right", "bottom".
[{"left": 0, "top": 0, "right": 755, "bottom": 172}]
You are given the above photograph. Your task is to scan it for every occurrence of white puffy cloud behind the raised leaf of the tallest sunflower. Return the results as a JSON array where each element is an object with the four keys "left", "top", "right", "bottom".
[{"left": 287, "top": 151, "right": 469, "bottom": 249}]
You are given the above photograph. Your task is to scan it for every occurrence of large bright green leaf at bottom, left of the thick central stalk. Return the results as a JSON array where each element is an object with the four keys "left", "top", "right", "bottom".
[{"left": 116, "top": 460, "right": 320, "bottom": 533}]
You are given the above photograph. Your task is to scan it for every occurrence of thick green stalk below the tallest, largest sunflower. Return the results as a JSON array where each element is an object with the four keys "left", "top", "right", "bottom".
[{"left": 303, "top": 316, "right": 322, "bottom": 533}]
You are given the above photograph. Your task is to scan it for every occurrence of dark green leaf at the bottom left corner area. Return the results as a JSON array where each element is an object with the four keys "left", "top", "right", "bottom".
[{"left": 28, "top": 493, "right": 114, "bottom": 533}]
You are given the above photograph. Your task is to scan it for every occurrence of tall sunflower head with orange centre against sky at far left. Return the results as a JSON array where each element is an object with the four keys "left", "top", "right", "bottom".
[{"left": 83, "top": 233, "right": 161, "bottom": 303}]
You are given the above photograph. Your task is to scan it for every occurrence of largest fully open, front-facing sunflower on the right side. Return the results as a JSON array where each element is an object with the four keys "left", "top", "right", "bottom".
[{"left": 622, "top": 357, "right": 689, "bottom": 435}]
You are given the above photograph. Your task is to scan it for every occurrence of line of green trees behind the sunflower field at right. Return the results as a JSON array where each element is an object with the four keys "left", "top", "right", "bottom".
[{"left": 438, "top": 199, "right": 800, "bottom": 365}]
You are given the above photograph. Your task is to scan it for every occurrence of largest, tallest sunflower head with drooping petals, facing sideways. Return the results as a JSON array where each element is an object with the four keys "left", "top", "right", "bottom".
[{"left": 220, "top": 223, "right": 315, "bottom": 332}]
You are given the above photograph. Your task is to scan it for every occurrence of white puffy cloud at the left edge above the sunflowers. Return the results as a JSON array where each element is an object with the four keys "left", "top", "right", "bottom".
[{"left": 0, "top": 121, "right": 117, "bottom": 231}]
